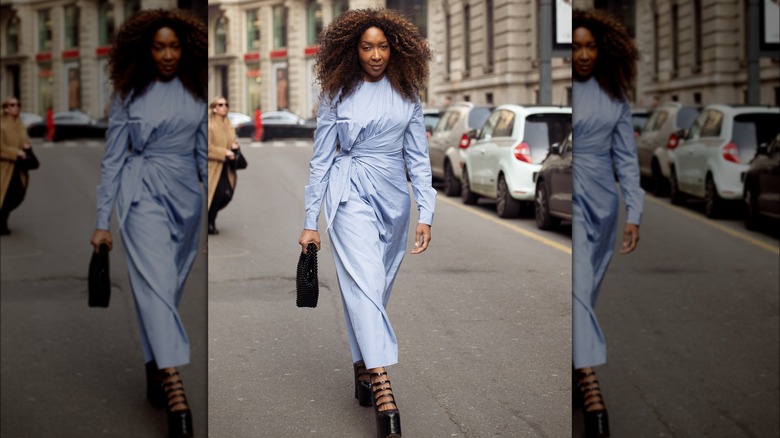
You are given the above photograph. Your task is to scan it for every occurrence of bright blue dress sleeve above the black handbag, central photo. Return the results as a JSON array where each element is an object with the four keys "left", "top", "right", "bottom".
[{"left": 303, "top": 98, "right": 336, "bottom": 230}]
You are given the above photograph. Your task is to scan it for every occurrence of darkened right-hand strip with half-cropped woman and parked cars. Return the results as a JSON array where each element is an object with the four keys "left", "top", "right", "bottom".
[{"left": 571, "top": 0, "right": 780, "bottom": 437}]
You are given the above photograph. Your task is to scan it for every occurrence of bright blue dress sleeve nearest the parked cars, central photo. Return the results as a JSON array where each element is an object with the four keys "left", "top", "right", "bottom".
[{"left": 404, "top": 100, "right": 436, "bottom": 225}]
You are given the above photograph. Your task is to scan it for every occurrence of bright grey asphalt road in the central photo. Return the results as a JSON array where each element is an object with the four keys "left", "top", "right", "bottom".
[{"left": 208, "top": 140, "right": 571, "bottom": 438}]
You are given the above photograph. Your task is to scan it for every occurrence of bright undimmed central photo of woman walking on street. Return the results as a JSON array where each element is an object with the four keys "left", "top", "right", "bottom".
[{"left": 208, "top": 0, "right": 572, "bottom": 438}]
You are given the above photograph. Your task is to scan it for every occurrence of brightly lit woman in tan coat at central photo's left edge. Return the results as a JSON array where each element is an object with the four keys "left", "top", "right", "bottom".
[{"left": 208, "top": 96, "right": 238, "bottom": 234}]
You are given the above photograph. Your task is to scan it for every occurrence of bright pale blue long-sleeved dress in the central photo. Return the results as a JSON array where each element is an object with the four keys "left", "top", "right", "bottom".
[{"left": 304, "top": 77, "right": 436, "bottom": 368}]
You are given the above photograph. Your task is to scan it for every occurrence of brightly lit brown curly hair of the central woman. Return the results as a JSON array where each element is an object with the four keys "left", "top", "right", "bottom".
[{"left": 314, "top": 9, "right": 431, "bottom": 102}]
